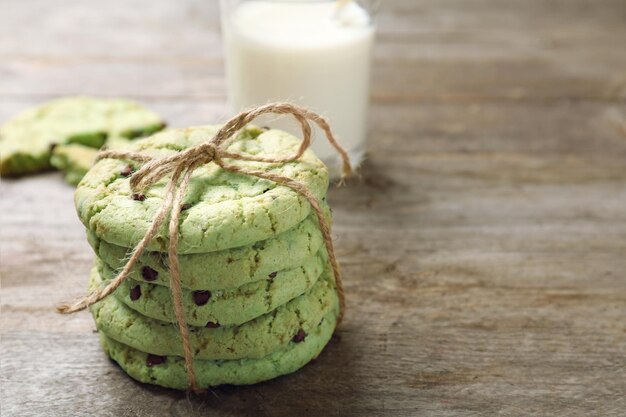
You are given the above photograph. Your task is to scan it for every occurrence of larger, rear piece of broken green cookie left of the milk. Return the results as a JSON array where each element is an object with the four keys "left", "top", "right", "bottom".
[{"left": 0, "top": 97, "right": 163, "bottom": 176}]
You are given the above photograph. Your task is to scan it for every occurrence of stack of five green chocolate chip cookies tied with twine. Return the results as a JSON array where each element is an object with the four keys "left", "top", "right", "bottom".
[{"left": 75, "top": 122, "right": 339, "bottom": 389}]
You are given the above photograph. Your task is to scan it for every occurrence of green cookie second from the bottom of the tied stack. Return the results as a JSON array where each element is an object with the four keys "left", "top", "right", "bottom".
[{"left": 91, "top": 262, "right": 339, "bottom": 359}]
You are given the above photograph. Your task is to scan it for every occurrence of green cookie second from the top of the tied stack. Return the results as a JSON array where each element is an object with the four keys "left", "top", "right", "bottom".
[{"left": 87, "top": 210, "right": 331, "bottom": 290}]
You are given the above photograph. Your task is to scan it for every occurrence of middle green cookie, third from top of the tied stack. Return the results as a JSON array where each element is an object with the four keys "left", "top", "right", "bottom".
[{"left": 99, "top": 247, "right": 327, "bottom": 326}]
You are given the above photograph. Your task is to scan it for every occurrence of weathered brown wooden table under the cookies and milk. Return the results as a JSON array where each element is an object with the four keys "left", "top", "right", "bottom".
[{"left": 0, "top": 0, "right": 626, "bottom": 417}]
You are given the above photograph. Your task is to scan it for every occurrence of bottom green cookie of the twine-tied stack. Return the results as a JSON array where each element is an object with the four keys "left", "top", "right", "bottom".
[{"left": 100, "top": 306, "right": 336, "bottom": 390}]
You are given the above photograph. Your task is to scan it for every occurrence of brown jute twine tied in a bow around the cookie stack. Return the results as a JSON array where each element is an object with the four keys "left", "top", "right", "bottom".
[{"left": 57, "top": 103, "right": 352, "bottom": 391}]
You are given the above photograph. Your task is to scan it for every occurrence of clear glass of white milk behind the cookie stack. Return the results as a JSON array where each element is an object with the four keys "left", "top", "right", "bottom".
[{"left": 222, "top": 0, "right": 378, "bottom": 176}]
